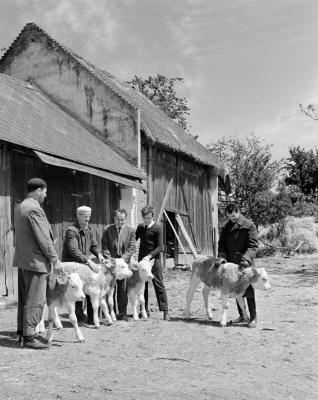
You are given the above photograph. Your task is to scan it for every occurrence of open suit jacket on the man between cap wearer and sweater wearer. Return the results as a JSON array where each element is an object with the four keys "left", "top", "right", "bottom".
[{"left": 102, "top": 224, "right": 136, "bottom": 264}]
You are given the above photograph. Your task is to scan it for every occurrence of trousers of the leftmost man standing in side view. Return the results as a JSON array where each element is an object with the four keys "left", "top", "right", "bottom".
[{"left": 17, "top": 268, "right": 48, "bottom": 340}]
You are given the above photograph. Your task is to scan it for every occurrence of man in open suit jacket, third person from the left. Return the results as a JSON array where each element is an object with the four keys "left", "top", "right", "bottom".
[{"left": 102, "top": 208, "right": 136, "bottom": 322}]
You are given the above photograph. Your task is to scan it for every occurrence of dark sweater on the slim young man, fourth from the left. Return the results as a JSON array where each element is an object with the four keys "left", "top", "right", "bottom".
[{"left": 136, "top": 223, "right": 163, "bottom": 261}]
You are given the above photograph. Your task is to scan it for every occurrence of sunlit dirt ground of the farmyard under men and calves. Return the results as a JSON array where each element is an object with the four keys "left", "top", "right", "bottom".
[{"left": 0, "top": 256, "right": 318, "bottom": 400}]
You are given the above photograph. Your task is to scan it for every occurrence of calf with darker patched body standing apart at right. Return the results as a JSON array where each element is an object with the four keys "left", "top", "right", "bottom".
[{"left": 185, "top": 256, "right": 270, "bottom": 327}]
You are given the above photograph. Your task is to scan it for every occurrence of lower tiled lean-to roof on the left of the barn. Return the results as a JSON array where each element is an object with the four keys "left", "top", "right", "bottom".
[{"left": 0, "top": 74, "right": 146, "bottom": 184}]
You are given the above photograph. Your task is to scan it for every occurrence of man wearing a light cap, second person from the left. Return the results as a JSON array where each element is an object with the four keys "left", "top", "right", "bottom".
[{"left": 62, "top": 206, "right": 105, "bottom": 325}]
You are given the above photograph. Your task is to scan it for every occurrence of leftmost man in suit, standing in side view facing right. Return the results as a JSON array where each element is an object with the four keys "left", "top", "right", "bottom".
[{"left": 13, "top": 178, "right": 62, "bottom": 350}]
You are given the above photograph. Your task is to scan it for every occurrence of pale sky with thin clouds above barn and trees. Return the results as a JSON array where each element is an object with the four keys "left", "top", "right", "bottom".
[{"left": 0, "top": 0, "right": 318, "bottom": 159}]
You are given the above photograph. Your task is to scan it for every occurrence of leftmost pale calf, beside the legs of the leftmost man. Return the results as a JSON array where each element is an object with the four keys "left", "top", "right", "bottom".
[{"left": 43, "top": 273, "right": 85, "bottom": 343}]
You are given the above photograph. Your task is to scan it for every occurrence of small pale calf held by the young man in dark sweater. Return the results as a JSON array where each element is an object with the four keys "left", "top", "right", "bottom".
[{"left": 127, "top": 260, "right": 154, "bottom": 321}]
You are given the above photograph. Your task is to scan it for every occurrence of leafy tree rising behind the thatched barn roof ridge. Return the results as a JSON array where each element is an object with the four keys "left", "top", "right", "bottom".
[{"left": 127, "top": 74, "right": 192, "bottom": 136}]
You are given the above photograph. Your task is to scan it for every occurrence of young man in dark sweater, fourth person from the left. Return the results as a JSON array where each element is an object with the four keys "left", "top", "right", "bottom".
[{"left": 136, "top": 206, "right": 170, "bottom": 321}]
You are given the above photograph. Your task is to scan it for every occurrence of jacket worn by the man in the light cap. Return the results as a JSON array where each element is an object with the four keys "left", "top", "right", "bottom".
[{"left": 62, "top": 222, "right": 100, "bottom": 263}]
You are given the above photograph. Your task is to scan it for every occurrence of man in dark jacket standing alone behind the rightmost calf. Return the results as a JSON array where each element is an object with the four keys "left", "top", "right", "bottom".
[{"left": 218, "top": 203, "right": 258, "bottom": 328}]
